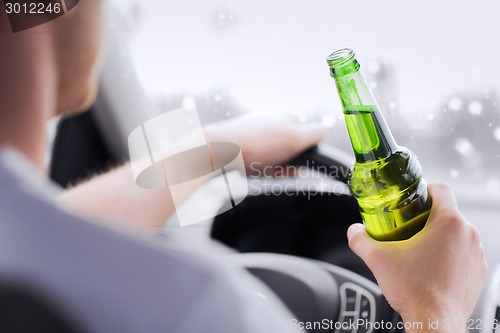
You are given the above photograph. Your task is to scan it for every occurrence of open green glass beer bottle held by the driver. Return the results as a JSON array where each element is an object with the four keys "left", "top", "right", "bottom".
[{"left": 327, "top": 49, "right": 431, "bottom": 241}]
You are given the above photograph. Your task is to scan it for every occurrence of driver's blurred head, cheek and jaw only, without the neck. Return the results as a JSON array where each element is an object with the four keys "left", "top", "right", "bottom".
[{"left": 0, "top": 0, "right": 102, "bottom": 117}]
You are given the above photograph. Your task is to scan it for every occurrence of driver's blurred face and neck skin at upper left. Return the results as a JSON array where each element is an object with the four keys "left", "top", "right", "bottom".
[{"left": 0, "top": 0, "right": 102, "bottom": 167}]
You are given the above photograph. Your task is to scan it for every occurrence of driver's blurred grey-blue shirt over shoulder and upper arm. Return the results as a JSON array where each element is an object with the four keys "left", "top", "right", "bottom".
[{"left": 0, "top": 150, "right": 294, "bottom": 333}]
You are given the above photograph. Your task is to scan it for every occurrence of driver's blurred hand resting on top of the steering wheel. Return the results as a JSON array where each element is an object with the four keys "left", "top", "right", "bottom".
[{"left": 205, "top": 114, "right": 323, "bottom": 171}]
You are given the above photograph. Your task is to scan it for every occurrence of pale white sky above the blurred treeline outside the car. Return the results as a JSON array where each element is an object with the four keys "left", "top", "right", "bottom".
[{"left": 123, "top": 0, "right": 500, "bottom": 118}]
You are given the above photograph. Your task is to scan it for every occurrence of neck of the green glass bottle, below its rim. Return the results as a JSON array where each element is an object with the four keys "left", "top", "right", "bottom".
[{"left": 332, "top": 70, "right": 398, "bottom": 163}]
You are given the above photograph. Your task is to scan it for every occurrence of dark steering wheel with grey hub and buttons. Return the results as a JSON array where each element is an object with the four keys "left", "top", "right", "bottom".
[{"left": 211, "top": 144, "right": 403, "bottom": 333}]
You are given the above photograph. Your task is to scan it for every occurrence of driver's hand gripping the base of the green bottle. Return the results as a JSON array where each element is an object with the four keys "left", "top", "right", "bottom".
[{"left": 348, "top": 185, "right": 488, "bottom": 332}]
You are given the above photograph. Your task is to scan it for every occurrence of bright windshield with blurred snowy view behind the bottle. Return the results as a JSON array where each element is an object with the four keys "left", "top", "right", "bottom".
[{"left": 116, "top": 0, "right": 500, "bottom": 206}]
